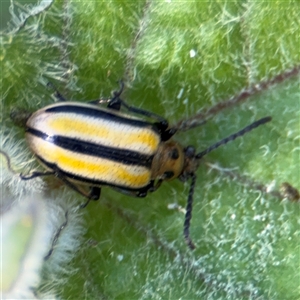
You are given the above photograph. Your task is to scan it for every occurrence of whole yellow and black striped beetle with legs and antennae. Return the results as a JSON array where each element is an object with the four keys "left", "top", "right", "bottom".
[{"left": 6, "top": 84, "right": 271, "bottom": 249}]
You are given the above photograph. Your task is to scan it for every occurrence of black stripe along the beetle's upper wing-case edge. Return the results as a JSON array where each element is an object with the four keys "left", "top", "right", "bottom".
[{"left": 45, "top": 104, "right": 158, "bottom": 133}]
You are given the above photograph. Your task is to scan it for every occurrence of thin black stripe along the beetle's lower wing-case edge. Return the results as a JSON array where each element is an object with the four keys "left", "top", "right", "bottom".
[{"left": 36, "top": 155, "right": 153, "bottom": 192}]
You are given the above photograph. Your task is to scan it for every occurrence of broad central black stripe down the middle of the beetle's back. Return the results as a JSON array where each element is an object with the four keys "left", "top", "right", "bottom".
[{"left": 26, "top": 127, "right": 153, "bottom": 168}]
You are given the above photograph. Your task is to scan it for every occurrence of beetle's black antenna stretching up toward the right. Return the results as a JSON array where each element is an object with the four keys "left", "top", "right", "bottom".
[{"left": 195, "top": 117, "right": 272, "bottom": 159}]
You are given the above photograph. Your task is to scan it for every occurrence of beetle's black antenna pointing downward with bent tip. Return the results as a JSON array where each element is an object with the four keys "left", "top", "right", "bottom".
[{"left": 183, "top": 173, "right": 197, "bottom": 250}]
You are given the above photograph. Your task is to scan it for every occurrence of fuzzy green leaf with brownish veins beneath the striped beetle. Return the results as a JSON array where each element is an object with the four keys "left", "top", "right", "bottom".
[{"left": 0, "top": 0, "right": 300, "bottom": 299}]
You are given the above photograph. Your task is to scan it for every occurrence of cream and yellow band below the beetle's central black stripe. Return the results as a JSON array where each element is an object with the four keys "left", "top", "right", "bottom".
[{"left": 29, "top": 136, "right": 151, "bottom": 188}]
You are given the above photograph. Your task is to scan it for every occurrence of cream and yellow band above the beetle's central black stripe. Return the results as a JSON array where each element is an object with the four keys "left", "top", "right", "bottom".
[{"left": 46, "top": 114, "right": 160, "bottom": 155}]
